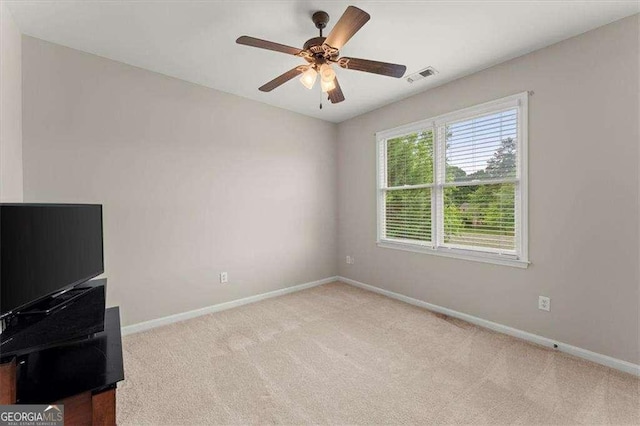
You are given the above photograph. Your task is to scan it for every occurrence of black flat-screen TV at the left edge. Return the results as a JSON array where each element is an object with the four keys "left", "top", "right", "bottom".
[{"left": 0, "top": 204, "right": 104, "bottom": 316}]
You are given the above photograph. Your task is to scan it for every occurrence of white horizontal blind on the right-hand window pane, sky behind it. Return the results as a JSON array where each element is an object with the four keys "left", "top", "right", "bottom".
[{"left": 439, "top": 108, "right": 518, "bottom": 253}]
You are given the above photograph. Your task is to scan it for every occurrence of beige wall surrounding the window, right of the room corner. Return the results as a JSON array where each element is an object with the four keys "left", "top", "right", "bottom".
[{"left": 338, "top": 15, "right": 640, "bottom": 363}]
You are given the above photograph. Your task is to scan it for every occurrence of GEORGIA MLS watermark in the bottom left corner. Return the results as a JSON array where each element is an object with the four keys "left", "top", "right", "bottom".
[{"left": 0, "top": 404, "right": 64, "bottom": 426}]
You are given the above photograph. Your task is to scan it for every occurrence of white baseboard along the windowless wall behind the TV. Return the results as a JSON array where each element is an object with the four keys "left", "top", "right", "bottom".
[{"left": 122, "top": 277, "right": 338, "bottom": 336}]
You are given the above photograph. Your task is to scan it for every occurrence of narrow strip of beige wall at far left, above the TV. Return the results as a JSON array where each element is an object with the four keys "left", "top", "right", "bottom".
[{"left": 0, "top": 3, "right": 22, "bottom": 202}]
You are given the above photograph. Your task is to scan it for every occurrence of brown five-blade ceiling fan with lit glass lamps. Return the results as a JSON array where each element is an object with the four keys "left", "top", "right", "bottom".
[{"left": 236, "top": 6, "right": 407, "bottom": 108}]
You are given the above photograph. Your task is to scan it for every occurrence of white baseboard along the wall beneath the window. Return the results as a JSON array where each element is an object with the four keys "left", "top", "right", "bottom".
[{"left": 338, "top": 277, "right": 640, "bottom": 376}]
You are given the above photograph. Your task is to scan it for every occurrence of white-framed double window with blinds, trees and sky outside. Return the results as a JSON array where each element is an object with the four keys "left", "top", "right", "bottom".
[{"left": 376, "top": 93, "right": 528, "bottom": 267}]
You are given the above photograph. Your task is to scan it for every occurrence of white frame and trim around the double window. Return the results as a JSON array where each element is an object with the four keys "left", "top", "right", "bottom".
[{"left": 376, "top": 92, "right": 529, "bottom": 268}]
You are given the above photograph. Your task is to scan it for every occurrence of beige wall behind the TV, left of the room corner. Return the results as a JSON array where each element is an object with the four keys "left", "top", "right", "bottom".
[{"left": 22, "top": 36, "right": 337, "bottom": 325}]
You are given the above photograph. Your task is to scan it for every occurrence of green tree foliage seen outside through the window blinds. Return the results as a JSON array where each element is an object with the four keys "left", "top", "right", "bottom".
[{"left": 386, "top": 132, "right": 517, "bottom": 248}]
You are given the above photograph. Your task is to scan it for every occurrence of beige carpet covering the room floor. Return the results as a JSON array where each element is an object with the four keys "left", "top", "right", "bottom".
[{"left": 117, "top": 283, "right": 640, "bottom": 425}]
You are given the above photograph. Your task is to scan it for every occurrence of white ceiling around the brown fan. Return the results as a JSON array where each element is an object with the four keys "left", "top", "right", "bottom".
[{"left": 7, "top": 0, "right": 640, "bottom": 122}]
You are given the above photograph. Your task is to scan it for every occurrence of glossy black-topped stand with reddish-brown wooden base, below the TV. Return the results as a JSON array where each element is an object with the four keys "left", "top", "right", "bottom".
[{"left": 0, "top": 307, "right": 124, "bottom": 426}]
